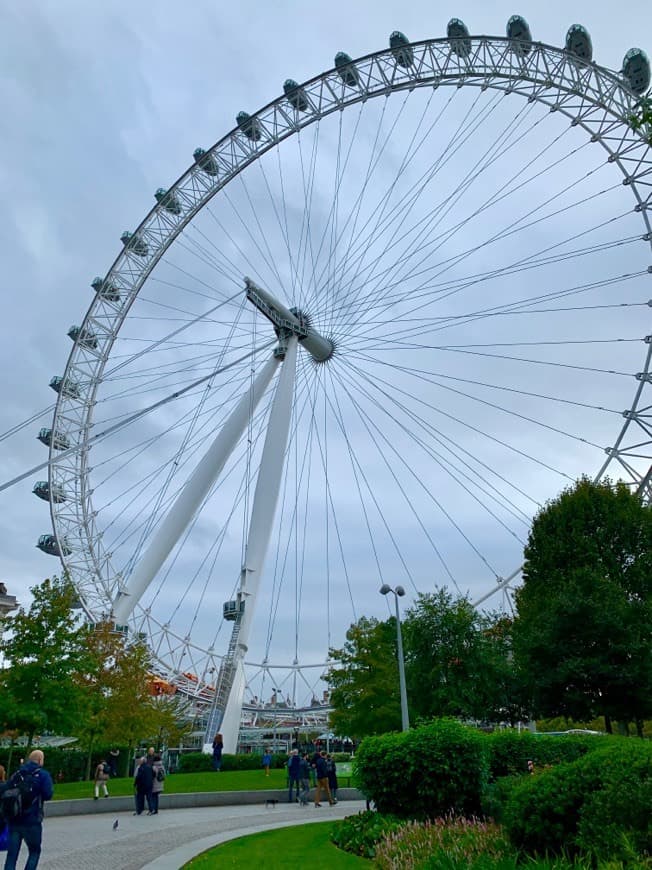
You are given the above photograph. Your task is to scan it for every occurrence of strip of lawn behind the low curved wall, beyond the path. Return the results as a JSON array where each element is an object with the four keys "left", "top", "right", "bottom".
[{"left": 54, "top": 768, "right": 287, "bottom": 800}]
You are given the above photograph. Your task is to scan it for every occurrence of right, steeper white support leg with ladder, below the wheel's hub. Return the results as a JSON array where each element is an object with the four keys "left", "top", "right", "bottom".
[{"left": 221, "top": 335, "right": 298, "bottom": 753}]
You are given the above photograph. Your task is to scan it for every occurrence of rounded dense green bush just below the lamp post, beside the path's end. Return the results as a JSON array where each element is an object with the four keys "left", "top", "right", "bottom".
[{"left": 355, "top": 719, "right": 487, "bottom": 819}]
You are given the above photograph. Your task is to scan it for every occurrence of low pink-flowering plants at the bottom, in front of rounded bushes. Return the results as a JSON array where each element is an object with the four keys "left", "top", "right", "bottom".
[{"left": 375, "top": 818, "right": 516, "bottom": 870}]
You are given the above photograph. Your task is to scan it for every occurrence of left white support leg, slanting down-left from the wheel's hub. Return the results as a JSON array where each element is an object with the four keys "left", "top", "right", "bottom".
[{"left": 113, "top": 354, "right": 279, "bottom": 623}]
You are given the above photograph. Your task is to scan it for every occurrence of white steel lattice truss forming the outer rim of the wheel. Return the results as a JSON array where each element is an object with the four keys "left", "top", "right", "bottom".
[{"left": 49, "top": 37, "right": 652, "bottom": 700}]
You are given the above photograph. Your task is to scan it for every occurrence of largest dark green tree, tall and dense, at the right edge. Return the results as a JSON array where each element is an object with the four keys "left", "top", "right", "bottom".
[{"left": 514, "top": 478, "right": 652, "bottom": 732}]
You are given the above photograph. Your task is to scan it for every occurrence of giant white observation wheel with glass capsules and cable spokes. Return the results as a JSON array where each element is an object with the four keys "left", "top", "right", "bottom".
[{"left": 35, "top": 16, "right": 652, "bottom": 748}]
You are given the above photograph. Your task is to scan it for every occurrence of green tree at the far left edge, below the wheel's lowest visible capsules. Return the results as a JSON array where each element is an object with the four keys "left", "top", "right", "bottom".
[{"left": 0, "top": 577, "right": 85, "bottom": 745}]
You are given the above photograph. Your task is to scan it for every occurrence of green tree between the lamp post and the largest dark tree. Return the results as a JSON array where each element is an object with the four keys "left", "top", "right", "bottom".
[{"left": 404, "top": 588, "right": 520, "bottom": 721}]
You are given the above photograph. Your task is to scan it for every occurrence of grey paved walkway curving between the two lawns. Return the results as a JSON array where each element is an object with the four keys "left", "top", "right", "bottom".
[{"left": 39, "top": 801, "right": 365, "bottom": 870}]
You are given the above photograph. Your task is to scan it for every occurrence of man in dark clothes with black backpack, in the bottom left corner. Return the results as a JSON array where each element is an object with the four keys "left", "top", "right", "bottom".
[{"left": 0, "top": 749, "right": 54, "bottom": 870}]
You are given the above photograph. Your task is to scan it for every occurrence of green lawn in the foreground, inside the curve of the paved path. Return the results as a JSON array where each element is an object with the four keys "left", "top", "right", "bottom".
[{"left": 183, "top": 822, "right": 371, "bottom": 870}]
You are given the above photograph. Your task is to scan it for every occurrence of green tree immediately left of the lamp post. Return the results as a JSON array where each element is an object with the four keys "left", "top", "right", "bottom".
[{"left": 326, "top": 617, "right": 401, "bottom": 739}]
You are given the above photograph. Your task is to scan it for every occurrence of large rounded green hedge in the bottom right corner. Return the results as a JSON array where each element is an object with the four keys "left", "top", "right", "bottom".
[{"left": 503, "top": 738, "right": 652, "bottom": 861}]
